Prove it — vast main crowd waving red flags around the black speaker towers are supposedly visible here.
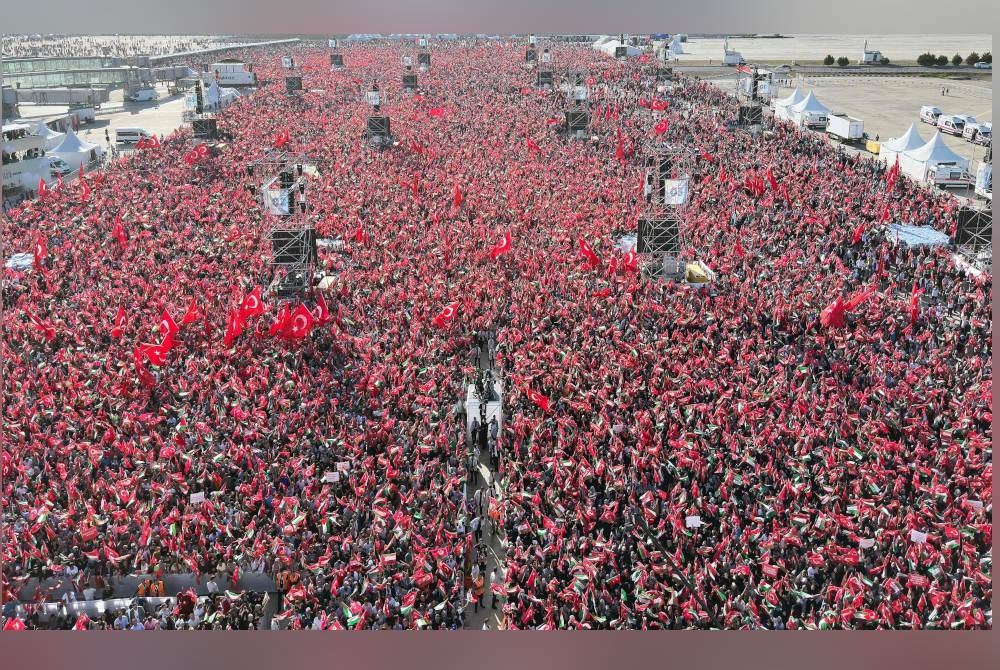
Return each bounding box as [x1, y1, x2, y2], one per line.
[0, 41, 992, 629]
